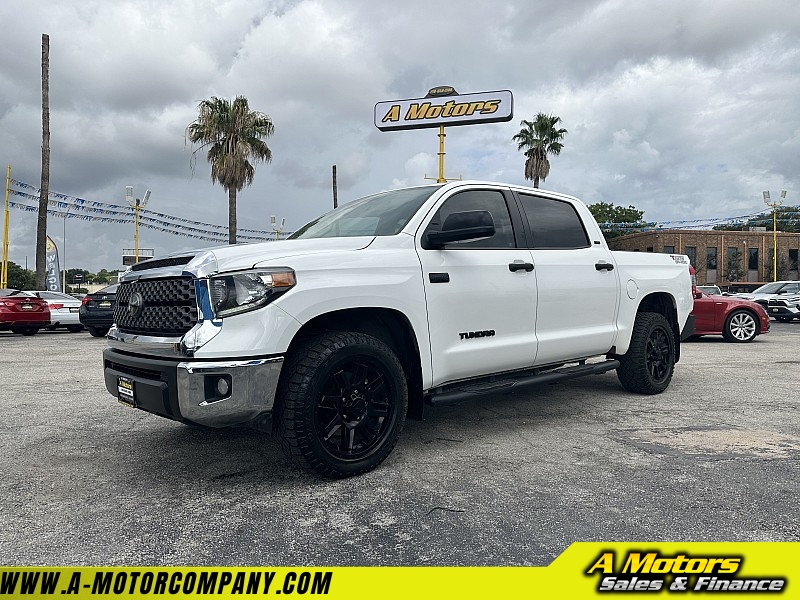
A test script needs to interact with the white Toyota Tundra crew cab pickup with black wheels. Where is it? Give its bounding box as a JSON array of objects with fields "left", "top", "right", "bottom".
[{"left": 103, "top": 181, "right": 693, "bottom": 477}]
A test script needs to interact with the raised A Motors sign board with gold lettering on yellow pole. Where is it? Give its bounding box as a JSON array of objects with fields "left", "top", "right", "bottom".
[{"left": 375, "top": 88, "right": 514, "bottom": 131}]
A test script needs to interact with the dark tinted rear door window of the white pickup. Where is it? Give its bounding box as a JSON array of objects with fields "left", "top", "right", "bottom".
[{"left": 520, "top": 194, "right": 589, "bottom": 248}]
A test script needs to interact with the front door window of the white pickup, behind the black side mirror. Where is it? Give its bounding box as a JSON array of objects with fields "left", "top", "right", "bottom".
[{"left": 425, "top": 190, "right": 516, "bottom": 250}]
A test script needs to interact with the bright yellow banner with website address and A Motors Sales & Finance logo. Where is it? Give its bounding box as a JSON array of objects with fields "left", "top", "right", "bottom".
[{"left": 0, "top": 542, "right": 800, "bottom": 600}]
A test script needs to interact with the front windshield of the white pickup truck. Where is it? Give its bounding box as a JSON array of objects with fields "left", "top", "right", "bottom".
[{"left": 288, "top": 185, "right": 440, "bottom": 240}]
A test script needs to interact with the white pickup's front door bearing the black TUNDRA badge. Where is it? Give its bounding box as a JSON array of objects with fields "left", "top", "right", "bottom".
[{"left": 417, "top": 188, "right": 537, "bottom": 385}]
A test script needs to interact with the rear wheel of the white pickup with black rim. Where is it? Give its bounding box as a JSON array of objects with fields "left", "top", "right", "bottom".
[{"left": 617, "top": 312, "right": 675, "bottom": 394}]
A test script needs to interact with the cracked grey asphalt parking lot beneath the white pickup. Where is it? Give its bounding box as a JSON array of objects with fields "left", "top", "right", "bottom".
[{"left": 0, "top": 322, "right": 800, "bottom": 566}]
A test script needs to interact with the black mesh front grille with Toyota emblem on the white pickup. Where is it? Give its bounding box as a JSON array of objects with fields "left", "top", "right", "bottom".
[{"left": 114, "top": 277, "right": 197, "bottom": 337}]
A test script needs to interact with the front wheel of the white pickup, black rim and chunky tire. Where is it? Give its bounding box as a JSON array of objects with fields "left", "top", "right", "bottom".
[{"left": 274, "top": 332, "right": 408, "bottom": 478}]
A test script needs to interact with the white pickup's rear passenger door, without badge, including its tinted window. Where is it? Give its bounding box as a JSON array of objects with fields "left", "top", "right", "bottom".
[{"left": 518, "top": 192, "right": 619, "bottom": 365}]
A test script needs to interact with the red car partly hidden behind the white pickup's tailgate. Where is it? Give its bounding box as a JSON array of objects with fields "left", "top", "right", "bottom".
[{"left": 692, "top": 290, "right": 770, "bottom": 343}]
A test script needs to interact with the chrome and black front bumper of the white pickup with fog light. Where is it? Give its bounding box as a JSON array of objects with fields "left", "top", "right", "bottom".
[{"left": 103, "top": 348, "right": 283, "bottom": 428}]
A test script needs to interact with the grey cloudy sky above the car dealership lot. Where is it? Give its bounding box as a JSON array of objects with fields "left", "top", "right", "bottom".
[{"left": 0, "top": 0, "right": 800, "bottom": 271}]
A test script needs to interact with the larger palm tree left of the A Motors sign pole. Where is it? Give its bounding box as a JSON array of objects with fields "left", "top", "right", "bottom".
[{"left": 186, "top": 96, "right": 275, "bottom": 244}]
